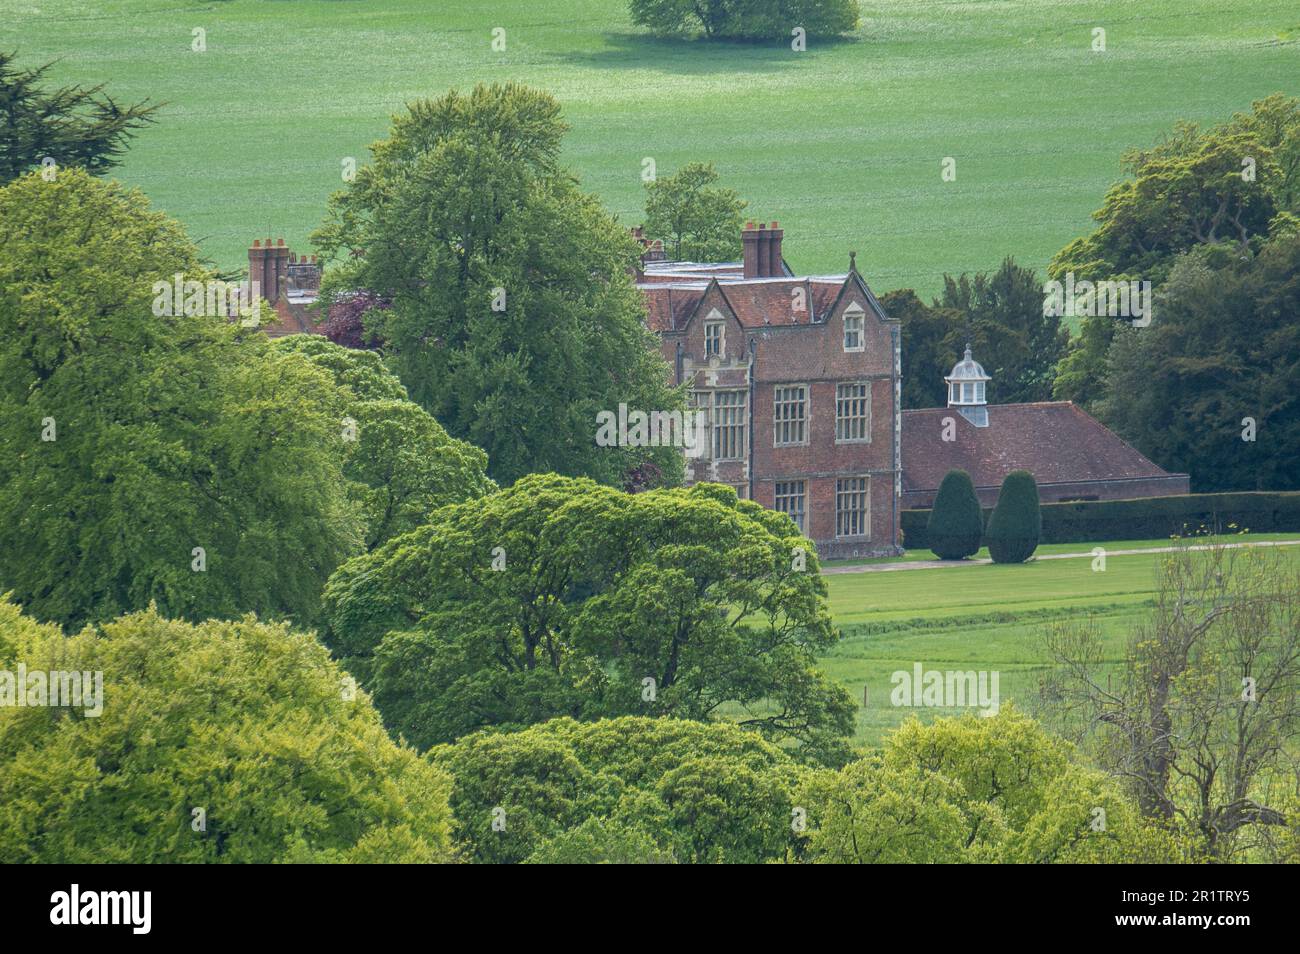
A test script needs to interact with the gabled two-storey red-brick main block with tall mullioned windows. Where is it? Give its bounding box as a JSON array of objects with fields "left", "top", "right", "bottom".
[{"left": 636, "top": 222, "right": 901, "bottom": 558}]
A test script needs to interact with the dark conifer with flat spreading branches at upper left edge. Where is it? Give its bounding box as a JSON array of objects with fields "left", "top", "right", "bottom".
[{"left": 0, "top": 51, "right": 161, "bottom": 185}]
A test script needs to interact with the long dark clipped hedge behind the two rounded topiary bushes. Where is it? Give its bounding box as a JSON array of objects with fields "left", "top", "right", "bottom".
[{"left": 901, "top": 491, "right": 1300, "bottom": 550}]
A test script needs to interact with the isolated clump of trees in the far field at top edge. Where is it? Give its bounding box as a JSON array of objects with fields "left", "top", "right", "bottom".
[{"left": 629, "top": 0, "right": 858, "bottom": 40}]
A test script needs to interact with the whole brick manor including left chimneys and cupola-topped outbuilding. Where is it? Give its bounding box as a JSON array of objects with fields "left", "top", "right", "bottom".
[{"left": 248, "top": 222, "right": 1188, "bottom": 559}]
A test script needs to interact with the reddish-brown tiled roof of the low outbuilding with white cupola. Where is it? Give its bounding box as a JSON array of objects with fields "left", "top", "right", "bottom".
[{"left": 900, "top": 402, "right": 1185, "bottom": 491}]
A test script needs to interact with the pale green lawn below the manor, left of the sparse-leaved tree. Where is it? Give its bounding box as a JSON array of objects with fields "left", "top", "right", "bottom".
[{"left": 822, "top": 534, "right": 1300, "bottom": 746}]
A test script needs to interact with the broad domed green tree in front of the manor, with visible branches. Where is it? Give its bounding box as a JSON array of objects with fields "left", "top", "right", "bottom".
[{"left": 322, "top": 474, "right": 854, "bottom": 763}]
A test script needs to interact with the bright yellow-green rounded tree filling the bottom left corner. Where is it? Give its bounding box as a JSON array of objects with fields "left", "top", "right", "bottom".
[{"left": 0, "top": 602, "right": 452, "bottom": 864}]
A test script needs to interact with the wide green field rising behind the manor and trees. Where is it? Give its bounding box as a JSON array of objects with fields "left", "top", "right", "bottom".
[{"left": 0, "top": 0, "right": 1300, "bottom": 292}]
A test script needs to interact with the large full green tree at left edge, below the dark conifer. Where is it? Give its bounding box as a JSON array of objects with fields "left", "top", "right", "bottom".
[{"left": 0, "top": 170, "right": 360, "bottom": 626}]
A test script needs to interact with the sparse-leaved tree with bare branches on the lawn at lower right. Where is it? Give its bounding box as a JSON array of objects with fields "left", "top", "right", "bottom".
[{"left": 1043, "top": 547, "right": 1300, "bottom": 860}]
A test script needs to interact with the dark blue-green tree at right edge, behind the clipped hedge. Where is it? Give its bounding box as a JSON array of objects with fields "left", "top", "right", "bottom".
[{"left": 1097, "top": 235, "right": 1300, "bottom": 491}]
